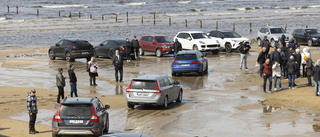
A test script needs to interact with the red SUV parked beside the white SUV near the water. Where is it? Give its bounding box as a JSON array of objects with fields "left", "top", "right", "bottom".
[{"left": 139, "top": 36, "right": 173, "bottom": 57}]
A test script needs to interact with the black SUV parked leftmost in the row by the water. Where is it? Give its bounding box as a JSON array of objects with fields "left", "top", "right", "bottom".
[{"left": 48, "top": 39, "right": 93, "bottom": 61}]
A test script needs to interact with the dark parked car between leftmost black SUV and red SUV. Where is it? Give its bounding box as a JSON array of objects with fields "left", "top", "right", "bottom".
[{"left": 93, "top": 40, "right": 135, "bottom": 59}]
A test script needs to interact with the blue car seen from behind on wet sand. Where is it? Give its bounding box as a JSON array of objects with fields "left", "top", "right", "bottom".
[{"left": 171, "top": 50, "right": 208, "bottom": 76}]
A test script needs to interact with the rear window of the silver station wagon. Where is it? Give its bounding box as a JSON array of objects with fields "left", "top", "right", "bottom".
[{"left": 130, "top": 80, "right": 156, "bottom": 90}]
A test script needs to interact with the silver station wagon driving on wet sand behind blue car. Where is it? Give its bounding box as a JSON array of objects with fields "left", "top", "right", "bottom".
[{"left": 126, "top": 75, "right": 183, "bottom": 109}]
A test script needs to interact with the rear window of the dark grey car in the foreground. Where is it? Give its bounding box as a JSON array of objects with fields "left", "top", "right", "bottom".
[{"left": 60, "top": 104, "right": 92, "bottom": 116}]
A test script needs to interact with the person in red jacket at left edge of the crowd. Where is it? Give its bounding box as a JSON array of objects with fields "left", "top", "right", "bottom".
[{"left": 262, "top": 59, "right": 272, "bottom": 93}]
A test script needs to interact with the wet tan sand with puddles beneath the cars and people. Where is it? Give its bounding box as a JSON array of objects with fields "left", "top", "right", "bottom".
[{"left": 0, "top": 44, "right": 320, "bottom": 137}]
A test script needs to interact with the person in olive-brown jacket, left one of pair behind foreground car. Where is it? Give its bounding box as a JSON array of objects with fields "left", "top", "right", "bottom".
[{"left": 56, "top": 68, "right": 66, "bottom": 103}]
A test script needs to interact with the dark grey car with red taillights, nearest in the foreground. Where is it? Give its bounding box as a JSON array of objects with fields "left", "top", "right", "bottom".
[{"left": 52, "top": 97, "right": 110, "bottom": 137}]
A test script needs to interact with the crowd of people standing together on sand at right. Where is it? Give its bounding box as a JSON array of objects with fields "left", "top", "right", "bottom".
[{"left": 257, "top": 36, "right": 320, "bottom": 96}]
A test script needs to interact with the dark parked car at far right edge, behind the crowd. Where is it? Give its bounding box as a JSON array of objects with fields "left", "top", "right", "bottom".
[{"left": 292, "top": 28, "right": 320, "bottom": 46}]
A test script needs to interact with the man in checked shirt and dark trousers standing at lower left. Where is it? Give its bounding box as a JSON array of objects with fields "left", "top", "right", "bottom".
[{"left": 27, "top": 89, "right": 39, "bottom": 134}]
